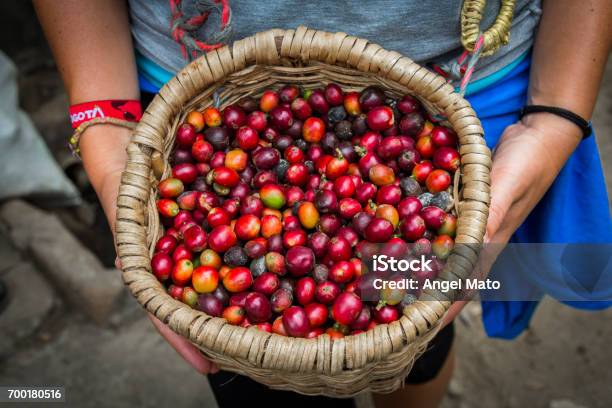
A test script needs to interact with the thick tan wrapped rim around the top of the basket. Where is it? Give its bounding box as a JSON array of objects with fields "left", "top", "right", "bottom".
[{"left": 116, "top": 26, "right": 491, "bottom": 371}]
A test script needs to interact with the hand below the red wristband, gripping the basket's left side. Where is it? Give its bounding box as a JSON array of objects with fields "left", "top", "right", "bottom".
[{"left": 81, "top": 125, "right": 219, "bottom": 374}]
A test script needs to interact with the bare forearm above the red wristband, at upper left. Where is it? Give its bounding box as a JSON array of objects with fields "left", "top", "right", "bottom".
[{"left": 34, "top": 0, "right": 139, "bottom": 104}]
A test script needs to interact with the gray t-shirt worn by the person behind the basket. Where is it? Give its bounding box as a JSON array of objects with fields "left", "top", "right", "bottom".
[{"left": 129, "top": 0, "right": 541, "bottom": 79}]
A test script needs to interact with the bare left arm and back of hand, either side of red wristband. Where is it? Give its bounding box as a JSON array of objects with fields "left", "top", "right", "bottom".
[{"left": 34, "top": 0, "right": 139, "bottom": 230}]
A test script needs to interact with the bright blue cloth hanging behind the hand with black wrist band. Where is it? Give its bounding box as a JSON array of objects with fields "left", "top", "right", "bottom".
[{"left": 468, "top": 58, "right": 612, "bottom": 339}]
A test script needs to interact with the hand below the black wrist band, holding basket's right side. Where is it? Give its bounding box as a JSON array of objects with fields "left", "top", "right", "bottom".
[{"left": 445, "top": 114, "right": 581, "bottom": 324}]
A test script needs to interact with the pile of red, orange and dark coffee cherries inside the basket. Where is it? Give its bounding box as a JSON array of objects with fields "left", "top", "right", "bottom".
[{"left": 151, "top": 83, "right": 460, "bottom": 338}]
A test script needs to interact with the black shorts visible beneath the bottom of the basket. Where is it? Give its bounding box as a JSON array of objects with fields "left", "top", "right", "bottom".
[{"left": 208, "top": 323, "right": 455, "bottom": 408}]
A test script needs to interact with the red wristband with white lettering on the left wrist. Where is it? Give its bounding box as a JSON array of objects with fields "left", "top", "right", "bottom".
[{"left": 70, "top": 100, "right": 142, "bottom": 129}]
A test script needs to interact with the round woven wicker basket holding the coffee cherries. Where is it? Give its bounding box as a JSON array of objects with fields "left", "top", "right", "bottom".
[{"left": 116, "top": 27, "right": 491, "bottom": 397}]
